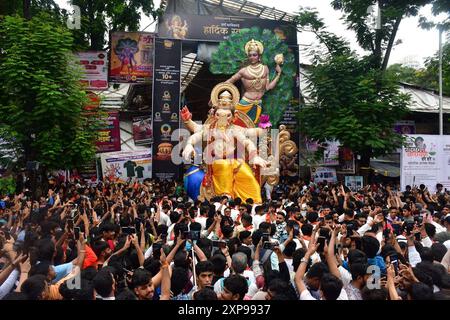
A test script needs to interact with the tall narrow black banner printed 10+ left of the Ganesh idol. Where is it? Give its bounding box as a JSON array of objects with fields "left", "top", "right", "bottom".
[{"left": 152, "top": 38, "right": 181, "bottom": 180}]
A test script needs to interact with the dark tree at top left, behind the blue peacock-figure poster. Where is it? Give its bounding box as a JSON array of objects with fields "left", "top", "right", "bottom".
[{"left": 70, "top": 0, "right": 165, "bottom": 50}]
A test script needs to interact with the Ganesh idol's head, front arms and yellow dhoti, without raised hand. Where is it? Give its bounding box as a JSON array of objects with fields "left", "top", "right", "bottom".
[{"left": 183, "top": 83, "right": 267, "bottom": 203}]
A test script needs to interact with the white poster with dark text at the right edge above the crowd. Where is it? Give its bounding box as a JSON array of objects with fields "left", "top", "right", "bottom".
[{"left": 400, "top": 135, "right": 450, "bottom": 192}]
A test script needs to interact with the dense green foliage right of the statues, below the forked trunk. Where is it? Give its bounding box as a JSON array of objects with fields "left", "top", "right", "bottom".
[{"left": 297, "top": 11, "right": 409, "bottom": 167}]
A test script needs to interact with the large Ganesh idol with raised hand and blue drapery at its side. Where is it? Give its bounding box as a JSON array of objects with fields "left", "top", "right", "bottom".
[{"left": 181, "top": 83, "right": 270, "bottom": 203}]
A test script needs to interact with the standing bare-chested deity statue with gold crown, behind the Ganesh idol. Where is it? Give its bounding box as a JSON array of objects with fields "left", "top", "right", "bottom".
[{"left": 226, "top": 39, "right": 283, "bottom": 124}]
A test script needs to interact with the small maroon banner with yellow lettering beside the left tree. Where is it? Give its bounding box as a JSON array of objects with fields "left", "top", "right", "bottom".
[{"left": 96, "top": 111, "right": 121, "bottom": 153}]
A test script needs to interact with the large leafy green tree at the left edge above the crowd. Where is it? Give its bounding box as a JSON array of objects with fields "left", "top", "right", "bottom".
[{"left": 0, "top": 14, "right": 100, "bottom": 180}]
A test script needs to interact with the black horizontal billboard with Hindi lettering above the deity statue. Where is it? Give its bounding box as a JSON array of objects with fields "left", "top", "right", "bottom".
[{"left": 158, "top": 13, "right": 297, "bottom": 46}]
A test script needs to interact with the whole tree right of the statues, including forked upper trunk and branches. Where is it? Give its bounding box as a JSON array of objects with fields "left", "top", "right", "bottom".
[{"left": 296, "top": 0, "right": 424, "bottom": 166}]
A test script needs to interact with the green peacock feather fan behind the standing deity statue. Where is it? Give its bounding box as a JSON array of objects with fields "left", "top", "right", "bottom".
[{"left": 210, "top": 27, "right": 296, "bottom": 126}]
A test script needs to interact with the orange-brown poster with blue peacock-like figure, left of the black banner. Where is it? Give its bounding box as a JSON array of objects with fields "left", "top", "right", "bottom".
[{"left": 109, "top": 32, "right": 154, "bottom": 83}]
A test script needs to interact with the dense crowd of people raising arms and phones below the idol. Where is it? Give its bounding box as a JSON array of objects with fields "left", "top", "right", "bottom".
[{"left": 0, "top": 179, "right": 450, "bottom": 300}]
